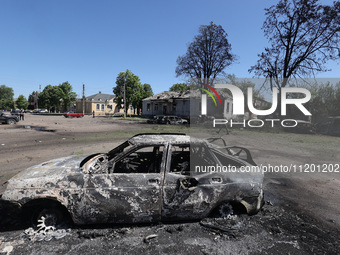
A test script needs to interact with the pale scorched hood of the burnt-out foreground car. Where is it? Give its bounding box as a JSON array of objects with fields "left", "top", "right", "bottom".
[{"left": 9, "top": 156, "right": 84, "bottom": 186}]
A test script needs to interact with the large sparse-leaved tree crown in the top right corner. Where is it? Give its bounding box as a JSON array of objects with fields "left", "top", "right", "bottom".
[{"left": 249, "top": 0, "right": 340, "bottom": 92}]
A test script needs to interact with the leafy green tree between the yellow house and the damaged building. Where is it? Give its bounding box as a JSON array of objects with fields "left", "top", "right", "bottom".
[{"left": 113, "top": 70, "right": 143, "bottom": 114}]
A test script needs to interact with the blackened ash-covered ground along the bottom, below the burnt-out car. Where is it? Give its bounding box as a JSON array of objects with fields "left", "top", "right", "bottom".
[{"left": 0, "top": 202, "right": 340, "bottom": 254}]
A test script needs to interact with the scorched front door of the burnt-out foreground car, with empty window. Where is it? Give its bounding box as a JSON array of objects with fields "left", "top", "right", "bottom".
[{"left": 85, "top": 145, "right": 165, "bottom": 223}]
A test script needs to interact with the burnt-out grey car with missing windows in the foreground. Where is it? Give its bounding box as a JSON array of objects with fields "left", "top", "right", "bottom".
[{"left": 1, "top": 134, "right": 263, "bottom": 224}]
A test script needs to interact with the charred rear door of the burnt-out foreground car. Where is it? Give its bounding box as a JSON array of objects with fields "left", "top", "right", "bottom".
[{"left": 162, "top": 144, "right": 222, "bottom": 220}]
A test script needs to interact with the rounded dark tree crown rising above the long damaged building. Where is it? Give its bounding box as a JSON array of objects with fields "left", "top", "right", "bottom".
[{"left": 176, "top": 22, "right": 236, "bottom": 79}]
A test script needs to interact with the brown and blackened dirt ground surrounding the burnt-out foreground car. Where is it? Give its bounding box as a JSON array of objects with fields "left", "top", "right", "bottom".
[{"left": 0, "top": 114, "right": 340, "bottom": 254}]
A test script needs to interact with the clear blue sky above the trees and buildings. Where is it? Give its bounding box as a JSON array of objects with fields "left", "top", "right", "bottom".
[{"left": 0, "top": 0, "right": 340, "bottom": 97}]
